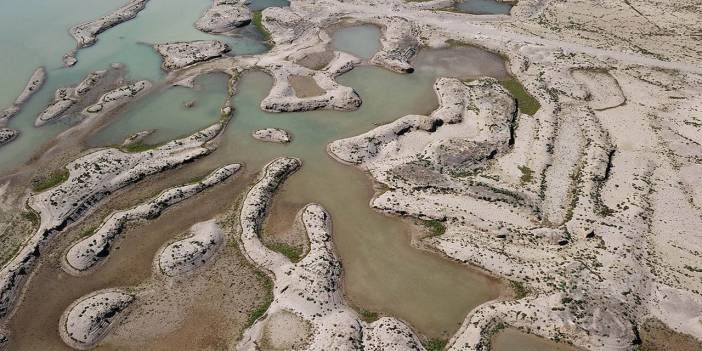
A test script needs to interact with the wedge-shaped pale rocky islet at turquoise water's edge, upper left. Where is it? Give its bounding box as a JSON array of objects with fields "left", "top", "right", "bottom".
[{"left": 154, "top": 40, "right": 229, "bottom": 71}]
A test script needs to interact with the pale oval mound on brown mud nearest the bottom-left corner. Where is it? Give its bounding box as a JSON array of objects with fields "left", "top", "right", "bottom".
[{"left": 59, "top": 289, "right": 134, "bottom": 350}]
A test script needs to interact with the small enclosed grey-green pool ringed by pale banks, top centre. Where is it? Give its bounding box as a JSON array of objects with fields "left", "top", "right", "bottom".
[{"left": 332, "top": 24, "right": 380, "bottom": 59}]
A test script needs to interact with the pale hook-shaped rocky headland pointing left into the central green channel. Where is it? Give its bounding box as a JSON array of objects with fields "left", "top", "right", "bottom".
[{"left": 329, "top": 78, "right": 516, "bottom": 174}]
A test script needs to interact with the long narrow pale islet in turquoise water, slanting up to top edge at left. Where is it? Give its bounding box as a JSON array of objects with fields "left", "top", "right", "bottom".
[{"left": 63, "top": 0, "right": 149, "bottom": 66}]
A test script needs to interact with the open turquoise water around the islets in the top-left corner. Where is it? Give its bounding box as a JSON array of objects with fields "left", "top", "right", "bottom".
[{"left": 0, "top": 0, "right": 267, "bottom": 174}]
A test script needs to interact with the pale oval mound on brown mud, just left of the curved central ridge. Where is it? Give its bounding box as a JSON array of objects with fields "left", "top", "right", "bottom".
[{"left": 156, "top": 220, "right": 224, "bottom": 277}]
